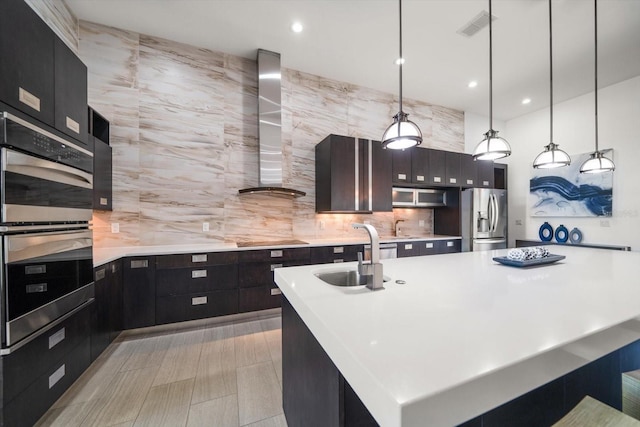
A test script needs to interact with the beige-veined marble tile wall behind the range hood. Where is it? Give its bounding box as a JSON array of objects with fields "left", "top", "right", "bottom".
[{"left": 78, "top": 21, "right": 464, "bottom": 247}]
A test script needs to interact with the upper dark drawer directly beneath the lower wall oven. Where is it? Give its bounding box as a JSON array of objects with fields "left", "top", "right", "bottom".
[{"left": 2, "top": 304, "right": 93, "bottom": 406}]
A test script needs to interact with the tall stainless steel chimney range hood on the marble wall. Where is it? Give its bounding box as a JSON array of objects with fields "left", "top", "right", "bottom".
[{"left": 238, "top": 49, "right": 306, "bottom": 197}]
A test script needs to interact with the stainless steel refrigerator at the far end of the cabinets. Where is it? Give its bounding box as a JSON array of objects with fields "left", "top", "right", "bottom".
[{"left": 460, "top": 188, "right": 507, "bottom": 252}]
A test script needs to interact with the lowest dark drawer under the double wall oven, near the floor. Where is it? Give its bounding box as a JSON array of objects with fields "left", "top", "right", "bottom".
[{"left": 3, "top": 336, "right": 91, "bottom": 427}]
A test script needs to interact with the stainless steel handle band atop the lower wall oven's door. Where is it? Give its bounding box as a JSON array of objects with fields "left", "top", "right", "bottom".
[{"left": 5, "top": 230, "right": 93, "bottom": 262}]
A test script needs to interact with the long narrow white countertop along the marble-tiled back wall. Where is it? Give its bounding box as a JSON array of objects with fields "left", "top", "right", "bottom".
[{"left": 93, "top": 233, "right": 461, "bottom": 266}]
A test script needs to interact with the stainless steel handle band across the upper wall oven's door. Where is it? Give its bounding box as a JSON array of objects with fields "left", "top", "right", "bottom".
[{"left": 2, "top": 150, "right": 93, "bottom": 189}]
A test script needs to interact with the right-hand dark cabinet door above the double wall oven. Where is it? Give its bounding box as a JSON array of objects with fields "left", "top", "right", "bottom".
[{"left": 54, "top": 37, "right": 88, "bottom": 145}]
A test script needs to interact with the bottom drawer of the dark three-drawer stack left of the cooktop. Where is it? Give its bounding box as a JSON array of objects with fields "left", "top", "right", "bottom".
[{"left": 156, "top": 289, "right": 238, "bottom": 324}]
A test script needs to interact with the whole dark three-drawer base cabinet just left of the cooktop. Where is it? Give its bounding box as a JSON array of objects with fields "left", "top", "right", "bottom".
[{"left": 156, "top": 252, "right": 238, "bottom": 324}]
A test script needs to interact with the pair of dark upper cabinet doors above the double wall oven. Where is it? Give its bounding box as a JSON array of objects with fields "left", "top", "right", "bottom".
[{"left": 0, "top": 0, "right": 90, "bottom": 149}]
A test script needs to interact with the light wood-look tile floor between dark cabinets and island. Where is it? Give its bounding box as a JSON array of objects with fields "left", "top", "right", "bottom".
[{"left": 36, "top": 314, "right": 287, "bottom": 427}]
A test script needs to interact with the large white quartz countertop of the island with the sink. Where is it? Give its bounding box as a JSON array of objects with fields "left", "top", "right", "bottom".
[{"left": 275, "top": 246, "right": 640, "bottom": 427}]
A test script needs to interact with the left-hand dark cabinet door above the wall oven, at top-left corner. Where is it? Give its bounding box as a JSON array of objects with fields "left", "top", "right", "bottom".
[{"left": 0, "top": 0, "right": 55, "bottom": 126}]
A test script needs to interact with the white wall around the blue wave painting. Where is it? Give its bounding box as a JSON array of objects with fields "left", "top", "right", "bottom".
[{"left": 500, "top": 76, "right": 640, "bottom": 251}]
